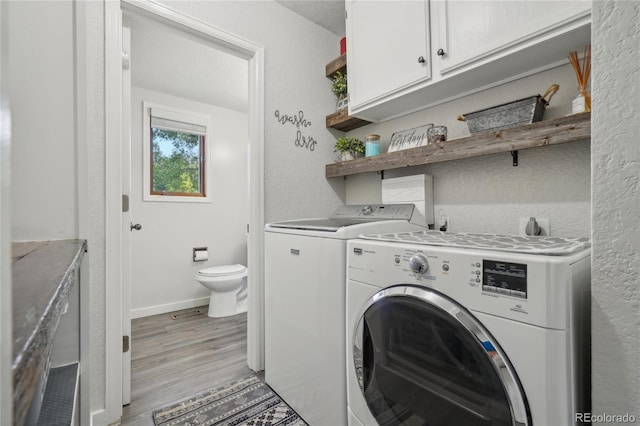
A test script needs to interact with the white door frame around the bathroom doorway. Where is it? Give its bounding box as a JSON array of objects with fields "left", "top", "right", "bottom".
[{"left": 104, "top": 0, "right": 264, "bottom": 420}]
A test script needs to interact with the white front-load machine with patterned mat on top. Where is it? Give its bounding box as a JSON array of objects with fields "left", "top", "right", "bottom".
[{"left": 346, "top": 231, "right": 590, "bottom": 426}]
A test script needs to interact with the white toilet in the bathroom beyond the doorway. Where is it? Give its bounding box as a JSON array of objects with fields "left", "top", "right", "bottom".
[{"left": 196, "top": 264, "right": 248, "bottom": 318}]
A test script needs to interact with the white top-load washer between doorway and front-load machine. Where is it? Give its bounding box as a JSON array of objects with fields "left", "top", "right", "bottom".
[{"left": 265, "top": 204, "right": 426, "bottom": 426}]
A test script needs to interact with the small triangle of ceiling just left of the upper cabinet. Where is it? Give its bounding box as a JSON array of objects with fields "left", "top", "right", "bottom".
[{"left": 276, "top": 0, "right": 346, "bottom": 37}]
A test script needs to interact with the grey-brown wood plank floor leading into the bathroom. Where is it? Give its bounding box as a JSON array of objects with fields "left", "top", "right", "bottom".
[{"left": 121, "top": 306, "right": 251, "bottom": 426}]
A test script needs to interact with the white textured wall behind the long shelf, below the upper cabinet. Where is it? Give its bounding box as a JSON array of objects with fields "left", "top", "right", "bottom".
[{"left": 347, "top": 64, "right": 591, "bottom": 236}]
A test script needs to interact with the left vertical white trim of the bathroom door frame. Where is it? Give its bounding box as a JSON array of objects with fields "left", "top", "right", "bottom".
[{"left": 104, "top": 1, "right": 122, "bottom": 424}]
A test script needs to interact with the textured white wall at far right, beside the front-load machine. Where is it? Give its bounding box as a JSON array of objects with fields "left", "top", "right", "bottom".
[{"left": 591, "top": 1, "right": 640, "bottom": 421}]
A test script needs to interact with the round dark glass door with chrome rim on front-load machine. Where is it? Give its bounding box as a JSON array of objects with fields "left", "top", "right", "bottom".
[{"left": 353, "top": 285, "right": 531, "bottom": 426}]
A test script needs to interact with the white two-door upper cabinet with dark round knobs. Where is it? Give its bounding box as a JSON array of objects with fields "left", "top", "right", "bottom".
[{"left": 346, "top": 0, "right": 591, "bottom": 121}]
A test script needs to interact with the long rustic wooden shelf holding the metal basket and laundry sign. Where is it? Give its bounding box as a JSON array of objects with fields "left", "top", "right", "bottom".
[{"left": 325, "top": 113, "right": 591, "bottom": 178}]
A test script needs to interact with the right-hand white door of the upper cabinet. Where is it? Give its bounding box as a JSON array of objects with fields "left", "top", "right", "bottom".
[{"left": 434, "top": 0, "right": 591, "bottom": 75}]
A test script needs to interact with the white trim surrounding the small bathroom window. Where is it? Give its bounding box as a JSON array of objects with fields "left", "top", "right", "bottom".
[{"left": 142, "top": 101, "right": 213, "bottom": 203}]
